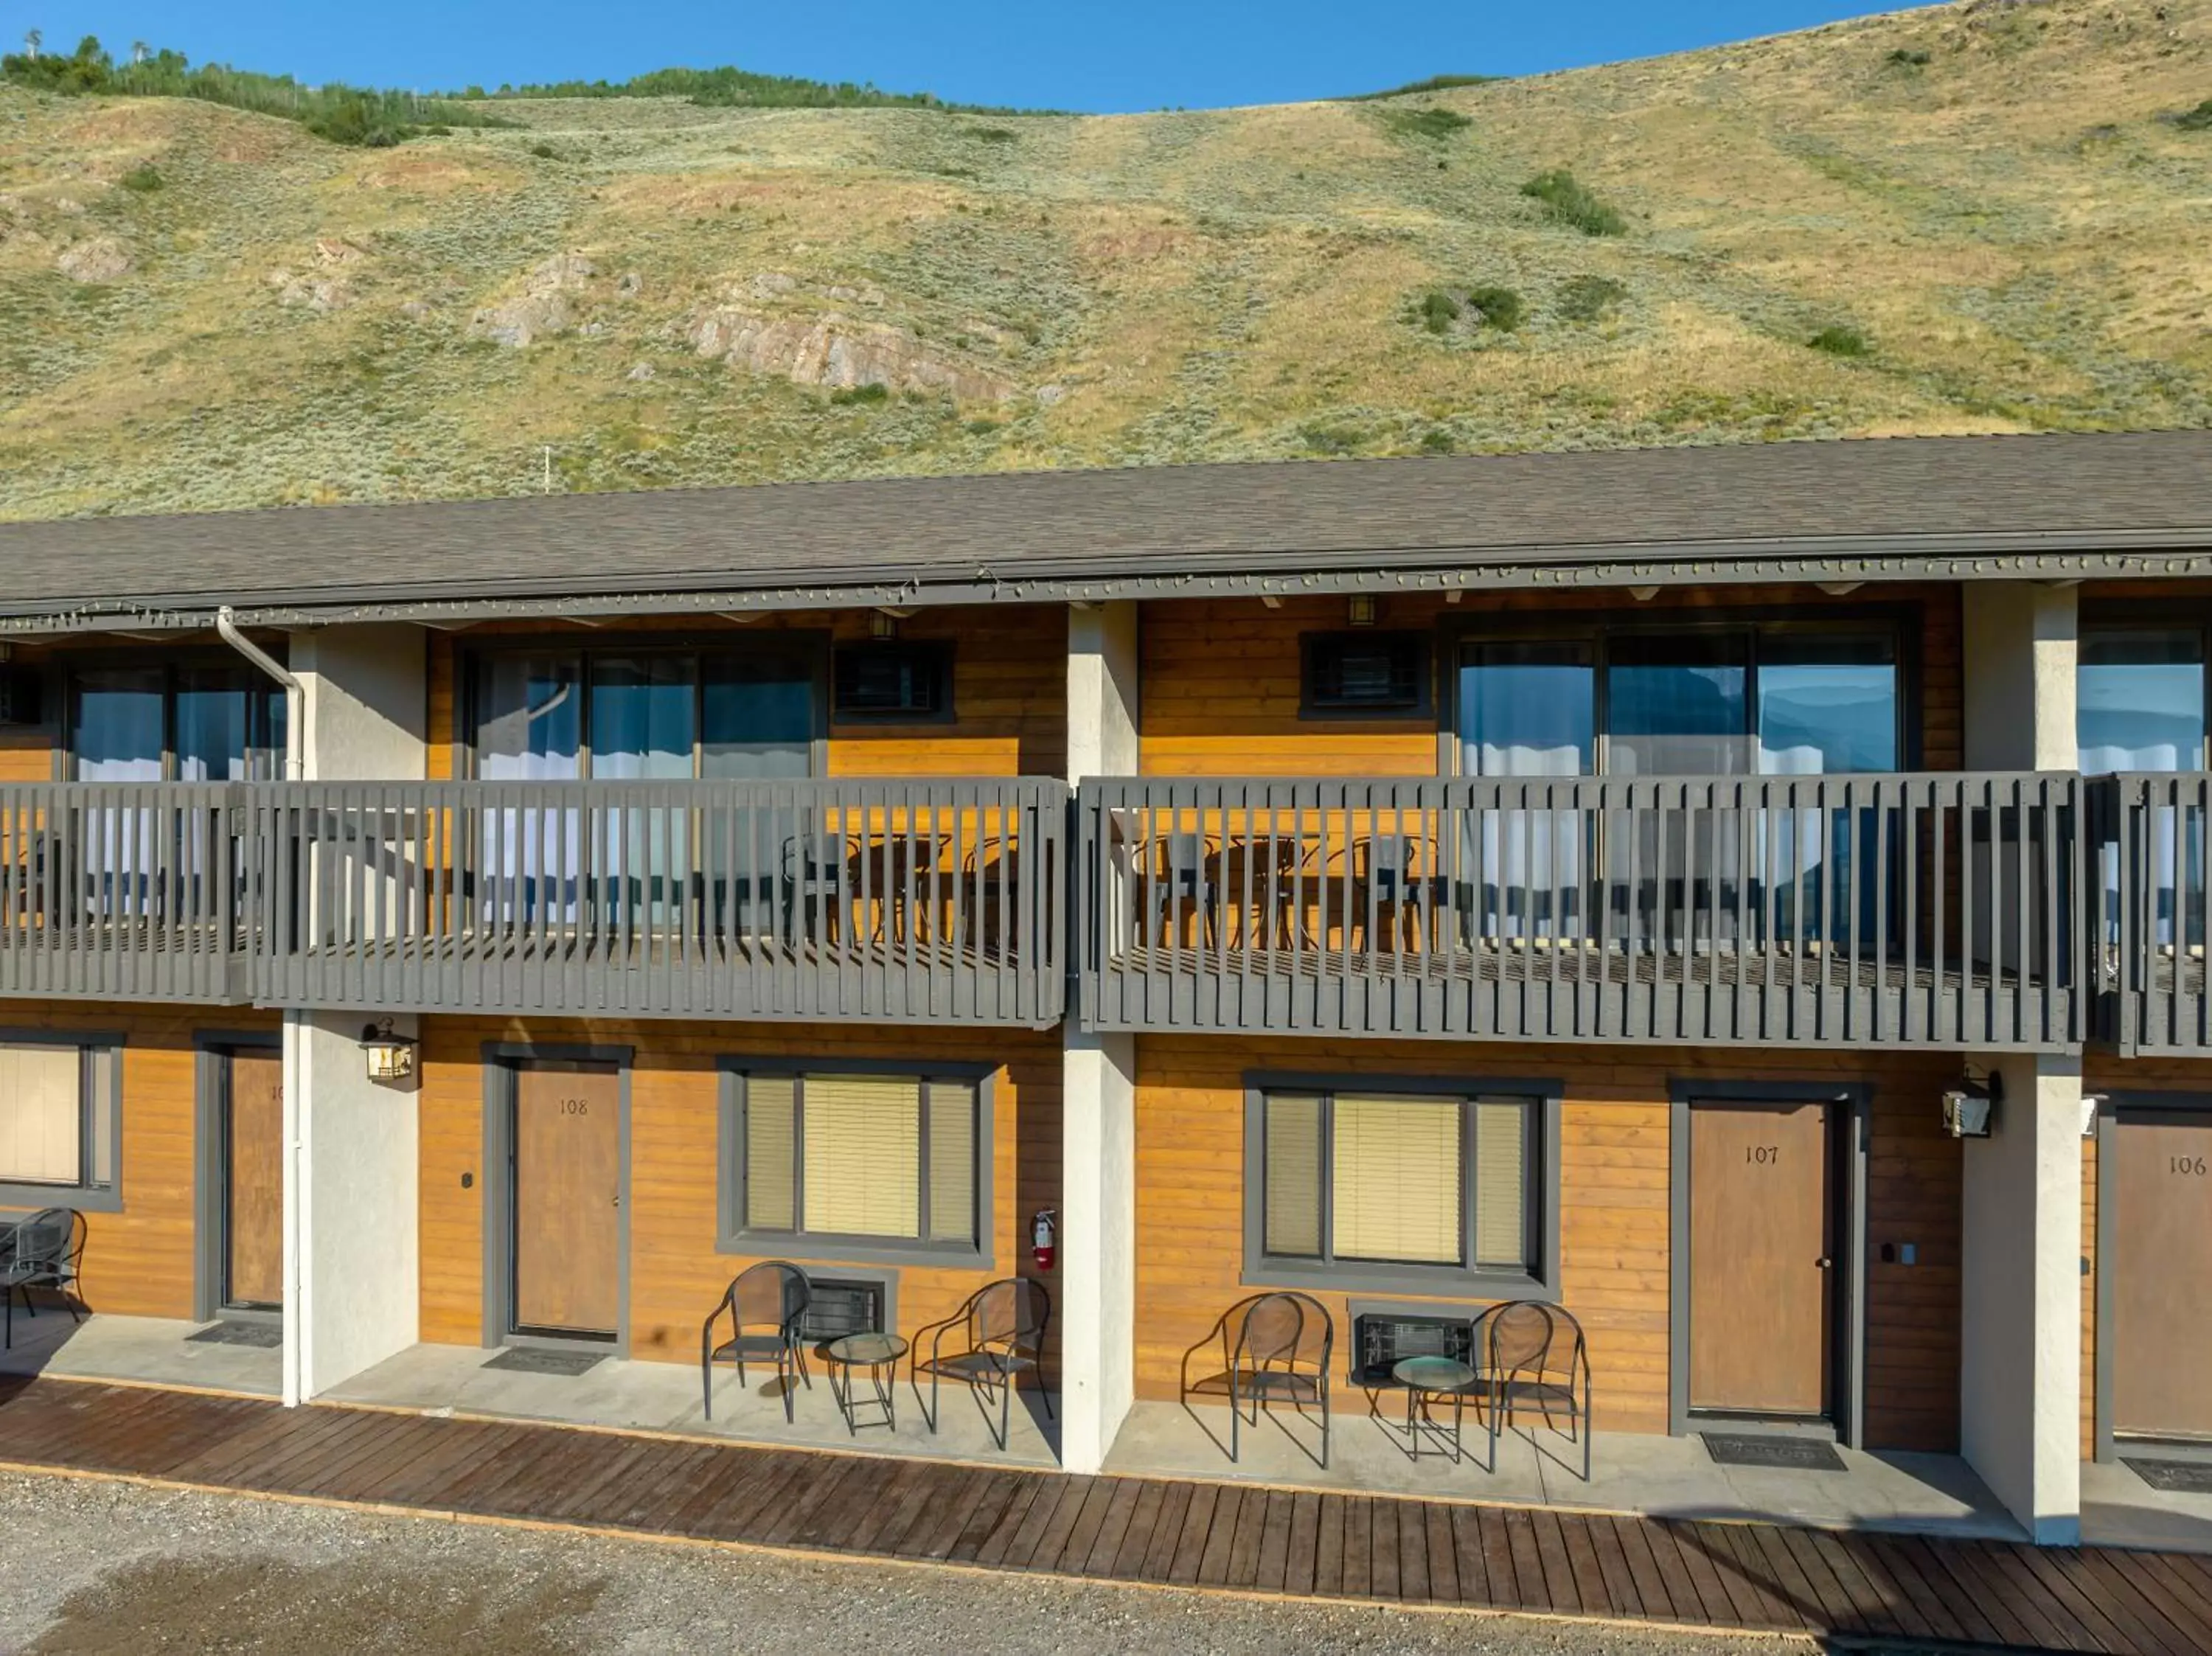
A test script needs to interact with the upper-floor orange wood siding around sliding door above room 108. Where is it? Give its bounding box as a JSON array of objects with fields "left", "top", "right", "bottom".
[{"left": 429, "top": 604, "right": 1068, "bottom": 781}]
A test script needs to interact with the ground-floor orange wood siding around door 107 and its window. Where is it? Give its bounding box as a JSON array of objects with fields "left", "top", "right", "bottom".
[{"left": 1137, "top": 1034, "right": 1960, "bottom": 1450}]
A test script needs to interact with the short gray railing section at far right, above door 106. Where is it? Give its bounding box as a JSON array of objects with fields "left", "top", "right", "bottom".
[{"left": 2088, "top": 772, "right": 2212, "bottom": 1054}]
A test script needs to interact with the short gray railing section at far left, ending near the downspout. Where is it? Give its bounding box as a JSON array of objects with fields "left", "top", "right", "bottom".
[{"left": 0, "top": 783, "right": 250, "bottom": 1001}]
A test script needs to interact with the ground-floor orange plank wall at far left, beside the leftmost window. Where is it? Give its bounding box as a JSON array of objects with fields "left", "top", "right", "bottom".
[{"left": 0, "top": 1001, "right": 276, "bottom": 1318}]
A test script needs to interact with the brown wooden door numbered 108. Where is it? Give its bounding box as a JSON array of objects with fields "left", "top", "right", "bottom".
[{"left": 513, "top": 1063, "right": 622, "bottom": 1337}]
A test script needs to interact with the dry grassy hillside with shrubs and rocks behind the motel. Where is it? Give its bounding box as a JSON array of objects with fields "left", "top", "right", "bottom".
[{"left": 0, "top": 0, "right": 2212, "bottom": 518}]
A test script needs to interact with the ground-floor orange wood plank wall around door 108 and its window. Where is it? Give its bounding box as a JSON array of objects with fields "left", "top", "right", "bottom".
[{"left": 420, "top": 1017, "right": 1060, "bottom": 1362}]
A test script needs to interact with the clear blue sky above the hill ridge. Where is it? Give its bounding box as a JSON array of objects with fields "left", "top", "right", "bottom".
[{"left": 17, "top": 0, "right": 1911, "bottom": 111}]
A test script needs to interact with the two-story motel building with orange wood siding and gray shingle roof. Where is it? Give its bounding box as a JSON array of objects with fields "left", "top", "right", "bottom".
[{"left": 0, "top": 431, "right": 2212, "bottom": 1543}]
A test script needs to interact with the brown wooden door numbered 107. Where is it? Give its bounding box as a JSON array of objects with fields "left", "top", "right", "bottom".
[{"left": 1690, "top": 1103, "right": 1836, "bottom": 1417}]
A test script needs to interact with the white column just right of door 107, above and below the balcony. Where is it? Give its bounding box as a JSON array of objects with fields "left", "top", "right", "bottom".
[{"left": 1964, "top": 582, "right": 2081, "bottom": 1545}]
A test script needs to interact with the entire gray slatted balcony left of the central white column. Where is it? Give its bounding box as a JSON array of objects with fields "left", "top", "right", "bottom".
[{"left": 0, "top": 781, "right": 1066, "bottom": 1028}]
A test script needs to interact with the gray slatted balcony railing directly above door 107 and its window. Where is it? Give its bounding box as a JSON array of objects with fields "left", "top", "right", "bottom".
[{"left": 1077, "top": 774, "right": 2086, "bottom": 1048}]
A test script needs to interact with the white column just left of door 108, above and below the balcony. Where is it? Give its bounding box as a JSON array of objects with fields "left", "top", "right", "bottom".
[{"left": 285, "top": 626, "right": 427, "bottom": 1402}]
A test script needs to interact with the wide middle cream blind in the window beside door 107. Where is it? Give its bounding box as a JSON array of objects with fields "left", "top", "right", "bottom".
[{"left": 1329, "top": 1094, "right": 1464, "bottom": 1264}]
